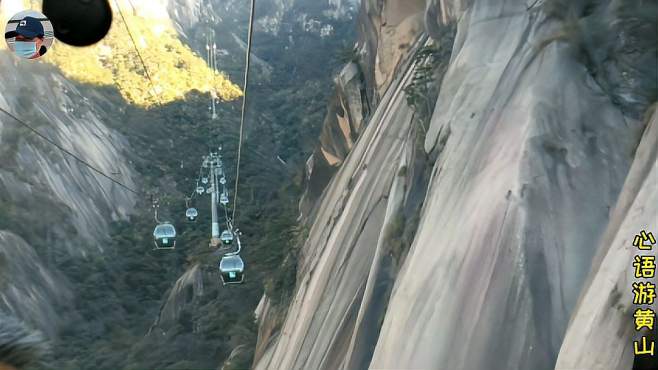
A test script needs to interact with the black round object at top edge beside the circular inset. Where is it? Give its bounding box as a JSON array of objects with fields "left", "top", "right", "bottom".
[{"left": 43, "top": 0, "right": 112, "bottom": 46}]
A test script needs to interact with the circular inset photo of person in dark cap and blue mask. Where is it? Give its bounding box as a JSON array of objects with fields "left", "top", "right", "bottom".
[{"left": 5, "top": 10, "right": 55, "bottom": 59}]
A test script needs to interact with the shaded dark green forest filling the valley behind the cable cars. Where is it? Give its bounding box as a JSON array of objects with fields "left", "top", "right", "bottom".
[{"left": 43, "top": 12, "right": 356, "bottom": 369}]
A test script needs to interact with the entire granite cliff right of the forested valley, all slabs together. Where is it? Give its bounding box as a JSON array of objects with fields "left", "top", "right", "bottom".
[{"left": 255, "top": 0, "right": 658, "bottom": 370}]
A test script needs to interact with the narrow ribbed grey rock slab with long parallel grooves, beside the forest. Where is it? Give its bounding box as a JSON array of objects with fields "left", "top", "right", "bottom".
[{"left": 255, "top": 39, "right": 413, "bottom": 369}]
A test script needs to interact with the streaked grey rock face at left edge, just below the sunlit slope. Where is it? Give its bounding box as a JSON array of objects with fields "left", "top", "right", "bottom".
[{"left": 0, "top": 52, "right": 135, "bottom": 253}]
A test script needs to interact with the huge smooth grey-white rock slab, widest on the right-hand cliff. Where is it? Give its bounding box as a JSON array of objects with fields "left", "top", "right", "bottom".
[{"left": 370, "top": 1, "right": 641, "bottom": 369}]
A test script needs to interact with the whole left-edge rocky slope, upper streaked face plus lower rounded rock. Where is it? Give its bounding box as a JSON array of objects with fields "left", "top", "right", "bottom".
[{"left": 0, "top": 53, "right": 135, "bottom": 335}]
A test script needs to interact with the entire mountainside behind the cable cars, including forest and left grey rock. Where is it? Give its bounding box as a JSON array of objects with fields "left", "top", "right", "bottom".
[{"left": 0, "top": 0, "right": 353, "bottom": 369}]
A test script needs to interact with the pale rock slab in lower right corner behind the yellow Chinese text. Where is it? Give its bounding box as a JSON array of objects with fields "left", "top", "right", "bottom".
[{"left": 555, "top": 109, "right": 658, "bottom": 370}]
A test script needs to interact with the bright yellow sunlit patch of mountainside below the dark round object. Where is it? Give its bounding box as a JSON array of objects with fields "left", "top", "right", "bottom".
[{"left": 45, "top": 8, "right": 242, "bottom": 107}]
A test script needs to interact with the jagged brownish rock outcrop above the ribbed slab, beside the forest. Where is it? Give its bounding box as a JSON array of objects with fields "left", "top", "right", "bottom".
[{"left": 300, "top": 0, "right": 424, "bottom": 218}]
